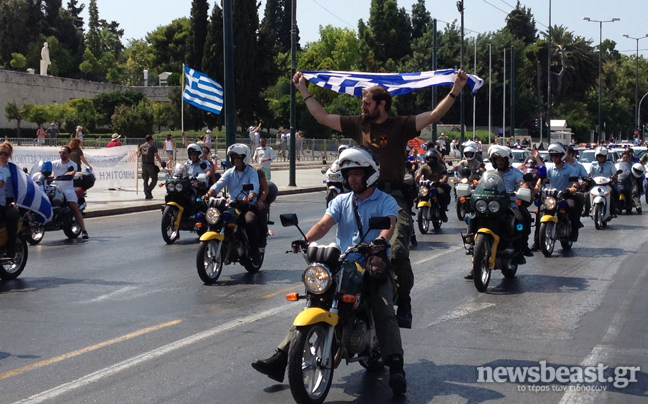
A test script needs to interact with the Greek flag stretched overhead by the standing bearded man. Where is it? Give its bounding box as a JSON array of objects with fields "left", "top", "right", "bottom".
[{"left": 302, "top": 69, "right": 484, "bottom": 97}]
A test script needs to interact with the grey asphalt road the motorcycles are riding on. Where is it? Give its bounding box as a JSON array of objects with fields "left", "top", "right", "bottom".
[{"left": 0, "top": 192, "right": 648, "bottom": 404}]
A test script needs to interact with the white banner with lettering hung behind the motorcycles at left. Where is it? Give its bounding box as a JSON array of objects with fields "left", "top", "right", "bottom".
[{"left": 11, "top": 146, "right": 137, "bottom": 189}]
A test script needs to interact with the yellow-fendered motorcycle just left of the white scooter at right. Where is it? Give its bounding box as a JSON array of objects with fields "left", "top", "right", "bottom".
[{"left": 538, "top": 188, "right": 573, "bottom": 257}]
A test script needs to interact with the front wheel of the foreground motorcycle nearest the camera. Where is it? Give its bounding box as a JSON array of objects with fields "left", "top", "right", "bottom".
[{"left": 288, "top": 323, "right": 333, "bottom": 404}]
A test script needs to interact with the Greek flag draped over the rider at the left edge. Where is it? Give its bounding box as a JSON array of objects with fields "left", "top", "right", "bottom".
[{"left": 8, "top": 163, "right": 52, "bottom": 224}]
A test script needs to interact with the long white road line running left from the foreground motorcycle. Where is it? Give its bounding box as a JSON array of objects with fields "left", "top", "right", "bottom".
[{"left": 9, "top": 305, "right": 286, "bottom": 404}]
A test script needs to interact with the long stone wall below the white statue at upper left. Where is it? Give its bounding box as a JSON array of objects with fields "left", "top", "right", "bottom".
[{"left": 0, "top": 70, "right": 171, "bottom": 129}]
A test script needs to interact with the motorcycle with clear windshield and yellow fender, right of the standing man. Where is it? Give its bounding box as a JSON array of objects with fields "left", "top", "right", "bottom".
[{"left": 457, "top": 171, "right": 531, "bottom": 292}]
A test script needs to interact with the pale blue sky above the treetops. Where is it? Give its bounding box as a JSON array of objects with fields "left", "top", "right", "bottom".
[{"left": 81, "top": 0, "right": 648, "bottom": 58}]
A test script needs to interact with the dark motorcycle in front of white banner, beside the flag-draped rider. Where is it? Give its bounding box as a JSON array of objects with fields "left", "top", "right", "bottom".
[{"left": 22, "top": 161, "right": 95, "bottom": 245}]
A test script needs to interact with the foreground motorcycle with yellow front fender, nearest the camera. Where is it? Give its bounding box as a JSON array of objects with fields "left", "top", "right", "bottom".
[{"left": 280, "top": 213, "right": 390, "bottom": 404}]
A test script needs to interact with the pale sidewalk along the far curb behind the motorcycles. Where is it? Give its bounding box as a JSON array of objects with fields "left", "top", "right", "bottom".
[{"left": 85, "top": 163, "right": 325, "bottom": 217}]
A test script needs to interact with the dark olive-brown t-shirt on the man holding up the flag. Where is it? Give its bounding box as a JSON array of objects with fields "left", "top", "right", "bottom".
[{"left": 340, "top": 115, "right": 420, "bottom": 184}]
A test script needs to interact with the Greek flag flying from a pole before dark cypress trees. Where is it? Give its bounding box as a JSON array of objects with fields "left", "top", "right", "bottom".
[{"left": 182, "top": 66, "right": 223, "bottom": 114}]
